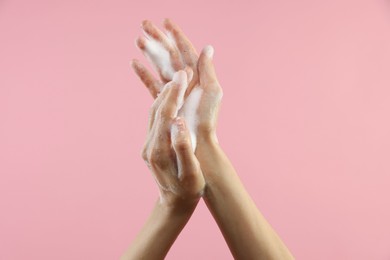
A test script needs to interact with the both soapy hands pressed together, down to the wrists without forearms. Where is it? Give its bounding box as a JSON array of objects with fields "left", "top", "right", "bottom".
[{"left": 132, "top": 19, "right": 222, "bottom": 208}]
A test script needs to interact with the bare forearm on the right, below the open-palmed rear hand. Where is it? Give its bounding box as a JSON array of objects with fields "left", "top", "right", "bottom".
[{"left": 197, "top": 142, "right": 293, "bottom": 260}]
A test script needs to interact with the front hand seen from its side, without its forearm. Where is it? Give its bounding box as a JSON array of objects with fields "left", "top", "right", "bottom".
[{"left": 142, "top": 71, "right": 205, "bottom": 208}]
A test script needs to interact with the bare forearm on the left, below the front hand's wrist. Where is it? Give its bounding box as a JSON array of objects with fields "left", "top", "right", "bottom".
[{"left": 121, "top": 200, "right": 196, "bottom": 260}]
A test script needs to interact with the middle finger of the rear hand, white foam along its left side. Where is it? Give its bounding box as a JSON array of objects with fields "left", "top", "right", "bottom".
[{"left": 142, "top": 20, "right": 184, "bottom": 80}]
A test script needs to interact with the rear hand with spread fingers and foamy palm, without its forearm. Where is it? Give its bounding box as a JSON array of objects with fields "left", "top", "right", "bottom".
[{"left": 132, "top": 19, "right": 222, "bottom": 150}]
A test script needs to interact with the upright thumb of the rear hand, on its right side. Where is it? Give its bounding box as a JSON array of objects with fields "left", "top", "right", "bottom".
[{"left": 198, "top": 45, "right": 219, "bottom": 87}]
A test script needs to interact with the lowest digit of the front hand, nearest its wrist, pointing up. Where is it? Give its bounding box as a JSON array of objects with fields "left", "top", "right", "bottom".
[{"left": 171, "top": 117, "right": 204, "bottom": 190}]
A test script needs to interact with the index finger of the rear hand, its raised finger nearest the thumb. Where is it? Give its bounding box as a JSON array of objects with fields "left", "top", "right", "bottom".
[{"left": 163, "top": 18, "right": 198, "bottom": 69}]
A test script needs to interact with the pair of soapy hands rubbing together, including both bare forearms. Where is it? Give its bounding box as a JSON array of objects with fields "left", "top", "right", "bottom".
[{"left": 128, "top": 19, "right": 294, "bottom": 260}]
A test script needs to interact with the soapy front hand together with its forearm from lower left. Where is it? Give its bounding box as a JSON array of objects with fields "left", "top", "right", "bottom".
[{"left": 121, "top": 71, "right": 205, "bottom": 260}]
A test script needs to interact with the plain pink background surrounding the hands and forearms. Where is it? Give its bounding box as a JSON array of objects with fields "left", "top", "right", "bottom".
[{"left": 0, "top": 0, "right": 390, "bottom": 260}]
